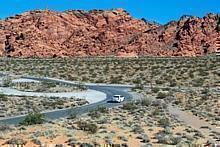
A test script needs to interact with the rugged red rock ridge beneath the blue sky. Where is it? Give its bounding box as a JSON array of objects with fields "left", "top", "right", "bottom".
[{"left": 0, "top": 9, "right": 219, "bottom": 57}]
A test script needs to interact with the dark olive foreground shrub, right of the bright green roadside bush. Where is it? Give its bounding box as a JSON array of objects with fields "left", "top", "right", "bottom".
[{"left": 77, "top": 121, "right": 98, "bottom": 134}]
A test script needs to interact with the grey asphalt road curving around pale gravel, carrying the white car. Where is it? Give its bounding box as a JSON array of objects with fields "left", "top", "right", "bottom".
[{"left": 0, "top": 76, "right": 132, "bottom": 125}]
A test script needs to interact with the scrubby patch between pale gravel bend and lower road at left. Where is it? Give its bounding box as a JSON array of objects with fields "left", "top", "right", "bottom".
[{"left": 0, "top": 94, "right": 88, "bottom": 117}]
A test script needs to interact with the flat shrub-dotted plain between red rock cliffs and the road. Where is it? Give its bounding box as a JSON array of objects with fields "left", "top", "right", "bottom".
[{"left": 0, "top": 57, "right": 217, "bottom": 89}]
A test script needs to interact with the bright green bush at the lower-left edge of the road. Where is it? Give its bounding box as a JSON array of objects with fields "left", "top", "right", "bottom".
[{"left": 21, "top": 112, "right": 45, "bottom": 126}]
